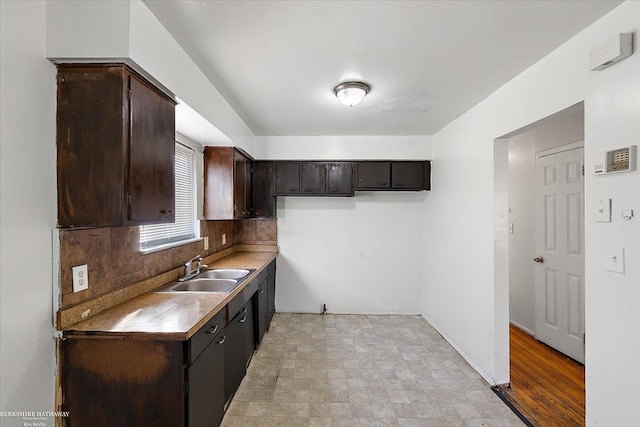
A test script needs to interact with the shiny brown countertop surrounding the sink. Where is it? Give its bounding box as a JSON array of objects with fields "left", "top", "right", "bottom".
[{"left": 63, "top": 252, "right": 278, "bottom": 341}]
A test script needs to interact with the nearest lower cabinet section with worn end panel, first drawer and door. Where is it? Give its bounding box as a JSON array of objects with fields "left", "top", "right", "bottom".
[{"left": 62, "top": 310, "right": 226, "bottom": 427}]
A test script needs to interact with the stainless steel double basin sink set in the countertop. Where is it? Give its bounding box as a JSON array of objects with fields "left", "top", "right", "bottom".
[{"left": 155, "top": 268, "right": 254, "bottom": 293}]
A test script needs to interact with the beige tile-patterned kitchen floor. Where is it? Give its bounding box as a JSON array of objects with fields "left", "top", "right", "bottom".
[{"left": 222, "top": 314, "right": 523, "bottom": 427}]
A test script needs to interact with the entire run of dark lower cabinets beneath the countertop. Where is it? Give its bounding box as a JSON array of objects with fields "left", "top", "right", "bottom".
[{"left": 62, "top": 266, "right": 275, "bottom": 427}]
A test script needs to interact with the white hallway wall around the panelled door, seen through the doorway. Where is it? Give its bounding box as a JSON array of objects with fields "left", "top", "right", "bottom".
[{"left": 508, "top": 108, "right": 584, "bottom": 334}]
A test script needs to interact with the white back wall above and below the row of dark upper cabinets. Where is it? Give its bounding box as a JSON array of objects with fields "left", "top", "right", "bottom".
[{"left": 256, "top": 136, "right": 431, "bottom": 314}]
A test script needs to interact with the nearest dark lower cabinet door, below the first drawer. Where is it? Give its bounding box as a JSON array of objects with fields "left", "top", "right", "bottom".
[{"left": 187, "top": 331, "right": 226, "bottom": 427}]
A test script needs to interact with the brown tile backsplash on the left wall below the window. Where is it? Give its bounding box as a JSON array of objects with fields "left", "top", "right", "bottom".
[{"left": 59, "top": 221, "right": 236, "bottom": 308}]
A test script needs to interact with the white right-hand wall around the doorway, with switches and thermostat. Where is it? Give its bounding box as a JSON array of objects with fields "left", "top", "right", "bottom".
[{"left": 423, "top": 2, "right": 640, "bottom": 426}]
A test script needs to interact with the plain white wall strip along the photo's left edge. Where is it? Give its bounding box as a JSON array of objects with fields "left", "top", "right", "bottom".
[{"left": 0, "top": 1, "right": 56, "bottom": 427}]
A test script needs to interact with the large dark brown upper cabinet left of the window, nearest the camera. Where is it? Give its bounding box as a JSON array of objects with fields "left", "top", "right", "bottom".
[{"left": 56, "top": 64, "right": 175, "bottom": 227}]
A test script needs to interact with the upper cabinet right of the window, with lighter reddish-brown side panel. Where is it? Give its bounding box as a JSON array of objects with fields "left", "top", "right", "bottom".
[{"left": 204, "top": 147, "right": 253, "bottom": 220}]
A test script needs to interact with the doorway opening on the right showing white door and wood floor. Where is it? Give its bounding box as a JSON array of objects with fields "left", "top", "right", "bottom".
[{"left": 495, "top": 103, "right": 584, "bottom": 425}]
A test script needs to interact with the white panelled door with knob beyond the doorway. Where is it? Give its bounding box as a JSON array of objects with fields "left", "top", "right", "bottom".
[{"left": 533, "top": 147, "right": 584, "bottom": 363}]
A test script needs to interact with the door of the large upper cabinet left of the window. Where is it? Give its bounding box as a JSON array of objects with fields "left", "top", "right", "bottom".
[{"left": 128, "top": 75, "right": 175, "bottom": 223}]
